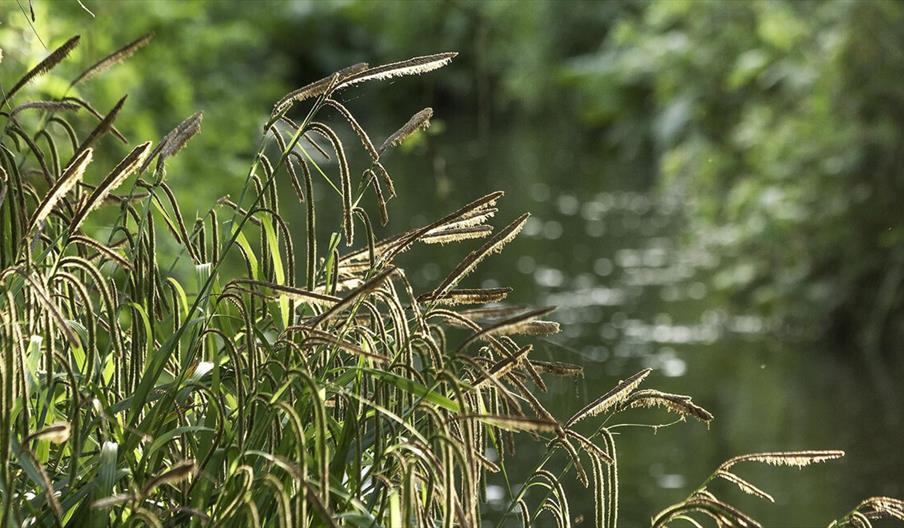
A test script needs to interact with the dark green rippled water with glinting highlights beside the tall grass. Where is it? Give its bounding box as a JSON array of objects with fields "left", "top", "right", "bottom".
[{"left": 300, "top": 111, "right": 904, "bottom": 527}]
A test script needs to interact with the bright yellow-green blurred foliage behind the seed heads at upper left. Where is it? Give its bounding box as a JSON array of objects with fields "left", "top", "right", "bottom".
[{"left": 0, "top": 0, "right": 288, "bottom": 210}]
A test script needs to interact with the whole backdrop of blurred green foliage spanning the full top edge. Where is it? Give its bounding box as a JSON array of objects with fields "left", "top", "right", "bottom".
[{"left": 7, "top": 0, "right": 904, "bottom": 353}]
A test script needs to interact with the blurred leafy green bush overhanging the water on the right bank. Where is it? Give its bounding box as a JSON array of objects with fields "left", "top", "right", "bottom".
[{"left": 572, "top": 0, "right": 904, "bottom": 358}]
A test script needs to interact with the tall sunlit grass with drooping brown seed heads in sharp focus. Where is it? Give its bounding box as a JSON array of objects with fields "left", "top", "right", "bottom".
[{"left": 0, "top": 32, "right": 902, "bottom": 527}]
